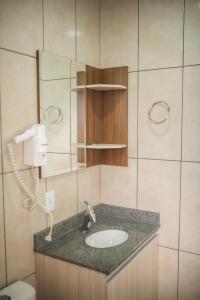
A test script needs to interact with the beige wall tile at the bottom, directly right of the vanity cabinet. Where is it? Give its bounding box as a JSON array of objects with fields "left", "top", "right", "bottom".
[{"left": 158, "top": 247, "right": 178, "bottom": 300}]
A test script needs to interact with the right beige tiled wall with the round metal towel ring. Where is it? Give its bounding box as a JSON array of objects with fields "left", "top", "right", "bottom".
[{"left": 100, "top": 0, "right": 200, "bottom": 300}]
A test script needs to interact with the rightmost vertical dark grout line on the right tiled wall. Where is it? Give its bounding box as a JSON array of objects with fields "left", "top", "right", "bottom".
[{"left": 177, "top": 0, "right": 185, "bottom": 299}]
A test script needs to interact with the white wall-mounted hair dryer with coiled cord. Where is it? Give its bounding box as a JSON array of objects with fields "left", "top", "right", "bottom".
[{"left": 8, "top": 124, "right": 53, "bottom": 241}]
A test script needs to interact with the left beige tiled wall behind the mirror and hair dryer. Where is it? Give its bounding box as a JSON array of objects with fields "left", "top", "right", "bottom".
[{"left": 0, "top": 0, "right": 100, "bottom": 287}]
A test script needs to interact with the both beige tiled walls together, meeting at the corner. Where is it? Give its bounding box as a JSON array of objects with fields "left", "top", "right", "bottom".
[{"left": 0, "top": 0, "right": 200, "bottom": 300}]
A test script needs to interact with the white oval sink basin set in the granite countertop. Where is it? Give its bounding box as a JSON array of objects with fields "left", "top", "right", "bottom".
[{"left": 85, "top": 229, "right": 128, "bottom": 248}]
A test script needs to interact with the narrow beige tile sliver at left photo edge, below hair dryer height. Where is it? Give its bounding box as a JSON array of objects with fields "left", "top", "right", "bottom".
[{"left": 0, "top": 175, "right": 6, "bottom": 288}]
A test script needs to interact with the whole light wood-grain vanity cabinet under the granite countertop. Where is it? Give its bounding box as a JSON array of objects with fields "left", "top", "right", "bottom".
[{"left": 36, "top": 237, "right": 157, "bottom": 300}]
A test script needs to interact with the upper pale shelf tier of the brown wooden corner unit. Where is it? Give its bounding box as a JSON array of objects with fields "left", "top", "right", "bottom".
[{"left": 72, "top": 84, "right": 127, "bottom": 91}]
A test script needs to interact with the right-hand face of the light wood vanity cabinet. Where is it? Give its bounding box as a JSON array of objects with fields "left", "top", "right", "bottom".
[{"left": 106, "top": 238, "right": 157, "bottom": 300}]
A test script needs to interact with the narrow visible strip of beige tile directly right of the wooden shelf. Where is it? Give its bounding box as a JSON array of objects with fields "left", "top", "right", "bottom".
[{"left": 128, "top": 73, "right": 137, "bottom": 157}]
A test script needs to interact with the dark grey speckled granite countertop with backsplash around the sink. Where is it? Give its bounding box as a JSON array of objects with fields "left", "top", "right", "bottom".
[{"left": 34, "top": 204, "right": 160, "bottom": 275}]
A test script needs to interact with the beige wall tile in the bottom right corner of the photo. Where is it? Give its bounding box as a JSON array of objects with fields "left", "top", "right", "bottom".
[{"left": 179, "top": 252, "right": 200, "bottom": 300}]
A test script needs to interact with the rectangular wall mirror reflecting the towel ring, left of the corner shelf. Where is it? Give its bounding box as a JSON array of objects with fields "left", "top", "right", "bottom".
[{"left": 37, "top": 51, "right": 86, "bottom": 178}]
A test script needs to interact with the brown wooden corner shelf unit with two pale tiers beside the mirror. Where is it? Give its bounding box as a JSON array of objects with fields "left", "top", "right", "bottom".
[{"left": 76, "top": 66, "right": 128, "bottom": 167}]
